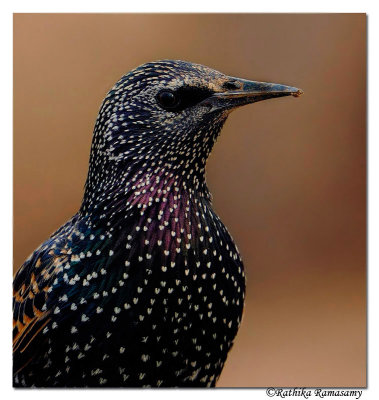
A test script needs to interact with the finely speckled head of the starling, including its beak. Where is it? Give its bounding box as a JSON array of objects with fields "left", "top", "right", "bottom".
[{"left": 86, "top": 60, "right": 302, "bottom": 212}]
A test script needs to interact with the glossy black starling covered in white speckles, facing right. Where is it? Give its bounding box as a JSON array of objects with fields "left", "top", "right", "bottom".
[{"left": 13, "top": 60, "right": 302, "bottom": 387}]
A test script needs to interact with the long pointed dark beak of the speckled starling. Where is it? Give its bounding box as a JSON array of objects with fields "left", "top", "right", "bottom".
[{"left": 204, "top": 77, "right": 303, "bottom": 111}]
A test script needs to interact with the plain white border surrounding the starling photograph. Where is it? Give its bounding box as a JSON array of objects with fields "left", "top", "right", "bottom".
[{"left": 0, "top": 0, "right": 379, "bottom": 400}]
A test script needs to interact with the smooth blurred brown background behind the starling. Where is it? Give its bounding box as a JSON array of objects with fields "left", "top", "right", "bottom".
[{"left": 14, "top": 14, "right": 366, "bottom": 387}]
